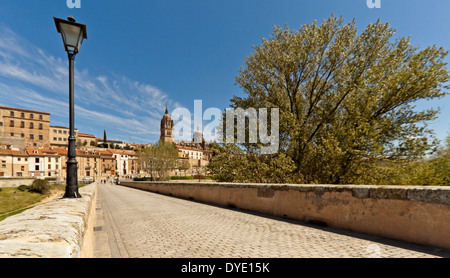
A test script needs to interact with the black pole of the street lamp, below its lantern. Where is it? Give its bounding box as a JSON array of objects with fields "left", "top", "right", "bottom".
[{"left": 64, "top": 52, "right": 81, "bottom": 198}]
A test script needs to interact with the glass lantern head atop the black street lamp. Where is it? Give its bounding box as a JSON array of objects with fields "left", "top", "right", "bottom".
[{"left": 53, "top": 17, "right": 87, "bottom": 54}]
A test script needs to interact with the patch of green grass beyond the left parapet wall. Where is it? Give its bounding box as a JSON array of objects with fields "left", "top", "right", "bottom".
[{"left": 0, "top": 185, "right": 65, "bottom": 221}]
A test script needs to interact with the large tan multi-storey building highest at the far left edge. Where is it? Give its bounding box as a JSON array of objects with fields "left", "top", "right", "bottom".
[{"left": 0, "top": 106, "right": 50, "bottom": 149}]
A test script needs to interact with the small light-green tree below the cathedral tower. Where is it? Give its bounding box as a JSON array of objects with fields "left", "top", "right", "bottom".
[{"left": 139, "top": 141, "right": 178, "bottom": 180}]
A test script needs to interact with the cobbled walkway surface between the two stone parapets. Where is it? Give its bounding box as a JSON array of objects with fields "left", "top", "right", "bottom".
[{"left": 94, "top": 184, "right": 450, "bottom": 258}]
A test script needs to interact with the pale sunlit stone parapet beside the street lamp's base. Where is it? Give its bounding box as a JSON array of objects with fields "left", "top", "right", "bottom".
[{"left": 0, "top": 183, "right": 97, "bottom": 258}]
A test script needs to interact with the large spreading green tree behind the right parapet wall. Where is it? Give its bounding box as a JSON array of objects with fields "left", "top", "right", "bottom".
[{"left": 222, "top": 15, "right": 450, "bottom": 183}]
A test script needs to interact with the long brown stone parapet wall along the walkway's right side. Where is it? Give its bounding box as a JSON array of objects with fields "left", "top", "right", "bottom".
[{"left": 121, "top": 182, "right": 450, "bottom": 249}]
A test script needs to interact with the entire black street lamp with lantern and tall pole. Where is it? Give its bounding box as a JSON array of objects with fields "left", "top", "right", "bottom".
[{"left": 53, "top": 16, "right": 87, "bottom": 198}]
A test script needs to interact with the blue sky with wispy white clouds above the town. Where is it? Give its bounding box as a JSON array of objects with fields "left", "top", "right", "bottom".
[{"left": 0, "top": 0, "right": 450, "bottom": 146}]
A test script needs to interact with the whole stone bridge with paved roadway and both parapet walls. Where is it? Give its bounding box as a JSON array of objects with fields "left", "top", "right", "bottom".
[{"left": 0, "top": 182, "right": 450, "bottom": 258}]
